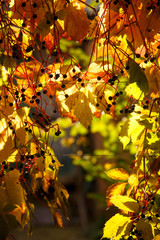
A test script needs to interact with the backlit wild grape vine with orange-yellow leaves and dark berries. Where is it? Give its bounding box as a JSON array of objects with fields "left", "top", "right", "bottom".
[{"left": 0, "top": 0, "right": 160, "bottom": 240}]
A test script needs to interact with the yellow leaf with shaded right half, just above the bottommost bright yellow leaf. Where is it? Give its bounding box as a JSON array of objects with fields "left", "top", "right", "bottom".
[{"left": 110, "top": 195, "right": 139, "bottom": 212}]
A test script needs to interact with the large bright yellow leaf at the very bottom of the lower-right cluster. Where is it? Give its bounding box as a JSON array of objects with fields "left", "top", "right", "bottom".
[{"left": 102, "top": 213, "right": 131, "bottom": 240}]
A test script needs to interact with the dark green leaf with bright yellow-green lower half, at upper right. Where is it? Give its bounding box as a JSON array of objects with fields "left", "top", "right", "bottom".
[{"left": 125, "top": 60, "right": 149, "bottom": 100}]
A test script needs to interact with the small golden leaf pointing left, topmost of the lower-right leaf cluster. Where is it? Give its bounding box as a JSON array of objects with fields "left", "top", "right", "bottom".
[{"left": 105, "top": 168, "right": 129, "bottom": 180}]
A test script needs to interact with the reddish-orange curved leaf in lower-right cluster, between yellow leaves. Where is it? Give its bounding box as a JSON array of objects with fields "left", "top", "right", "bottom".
[{"left": 106, "top": 183, "right": 127, "bottom": 207}]
